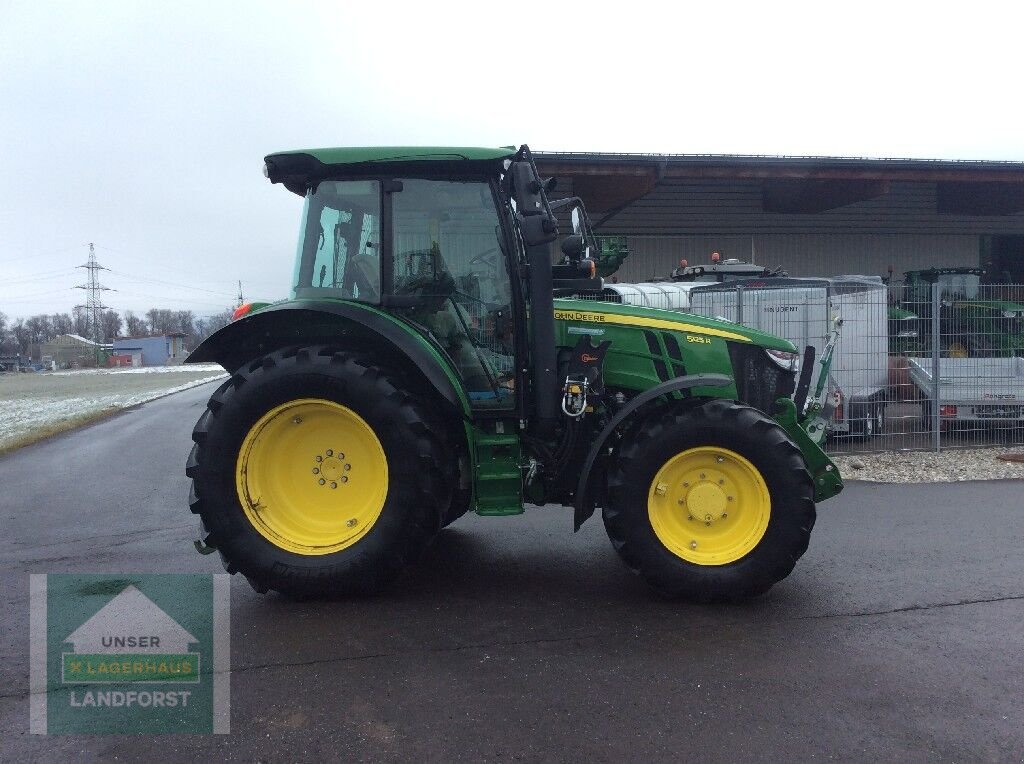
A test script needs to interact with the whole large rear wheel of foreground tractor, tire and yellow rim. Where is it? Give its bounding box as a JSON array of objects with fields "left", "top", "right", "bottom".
[{"left": 186, "top": 347, "right": 455, "bottom": 596}]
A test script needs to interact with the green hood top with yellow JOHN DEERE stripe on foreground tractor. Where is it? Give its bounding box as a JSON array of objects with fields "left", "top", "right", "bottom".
[{"left": 555, "top": 299, "right": 797, "bottom": 352}]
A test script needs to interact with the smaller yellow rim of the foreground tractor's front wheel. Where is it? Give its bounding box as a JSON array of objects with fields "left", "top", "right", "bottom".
[{"left": 647, "top": 445, "right": 771, "bottom": 565}]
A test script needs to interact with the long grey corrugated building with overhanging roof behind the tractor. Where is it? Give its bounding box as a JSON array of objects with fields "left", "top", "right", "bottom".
[{"left": 538, "top": 153, "right": 1024, "bottom": 283}]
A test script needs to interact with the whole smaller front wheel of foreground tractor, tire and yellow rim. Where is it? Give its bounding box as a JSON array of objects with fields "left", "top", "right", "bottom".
[{"left": 603, "top": 400, "right": 815, "bottom": 602}]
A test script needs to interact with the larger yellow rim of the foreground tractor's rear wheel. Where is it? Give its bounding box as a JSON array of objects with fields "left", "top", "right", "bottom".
[{"left": 236, "top": 398, "right": 388, "bottom": 555}]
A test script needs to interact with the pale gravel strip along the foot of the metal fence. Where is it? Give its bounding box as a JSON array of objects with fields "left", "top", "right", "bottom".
[{"left": 833, "top": 445, "right": 1024, "bottom": 482}]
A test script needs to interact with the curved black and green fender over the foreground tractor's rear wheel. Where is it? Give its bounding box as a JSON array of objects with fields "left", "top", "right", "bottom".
[{"left": 185, "top": 300, "right": 469, "bottom": 418}]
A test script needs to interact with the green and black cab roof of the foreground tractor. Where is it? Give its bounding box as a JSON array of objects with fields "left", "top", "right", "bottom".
[{"left": 265, "top": 145, "right": 518, "bottom": 195}]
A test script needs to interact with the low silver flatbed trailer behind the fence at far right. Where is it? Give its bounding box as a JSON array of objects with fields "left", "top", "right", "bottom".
[{"left": 907, "top": 355, "right": 1024, "bottom": 427}]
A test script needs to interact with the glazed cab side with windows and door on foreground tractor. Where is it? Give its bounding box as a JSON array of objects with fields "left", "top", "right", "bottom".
[{"left": 292, "top": 174, "right": 521, "bottom": 409}]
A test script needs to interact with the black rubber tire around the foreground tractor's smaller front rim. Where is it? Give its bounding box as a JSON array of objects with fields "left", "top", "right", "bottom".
[{"left": 603, "top": 400, "right": 815, "bottom": 602}]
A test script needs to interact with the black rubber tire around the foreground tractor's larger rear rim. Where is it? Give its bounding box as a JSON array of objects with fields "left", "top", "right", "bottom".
[{"left": 185, "top": 346, "right": 457, "bottom": 597}]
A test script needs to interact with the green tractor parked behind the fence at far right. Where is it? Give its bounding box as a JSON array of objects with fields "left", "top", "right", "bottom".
[{"left": 900, "top": 267, "right": 1024, "bottom": 357}]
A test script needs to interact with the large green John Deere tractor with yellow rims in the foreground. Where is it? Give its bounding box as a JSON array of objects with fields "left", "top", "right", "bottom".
[{"left": 186, "top": 146, "right": 843, "bottom": 601}]
